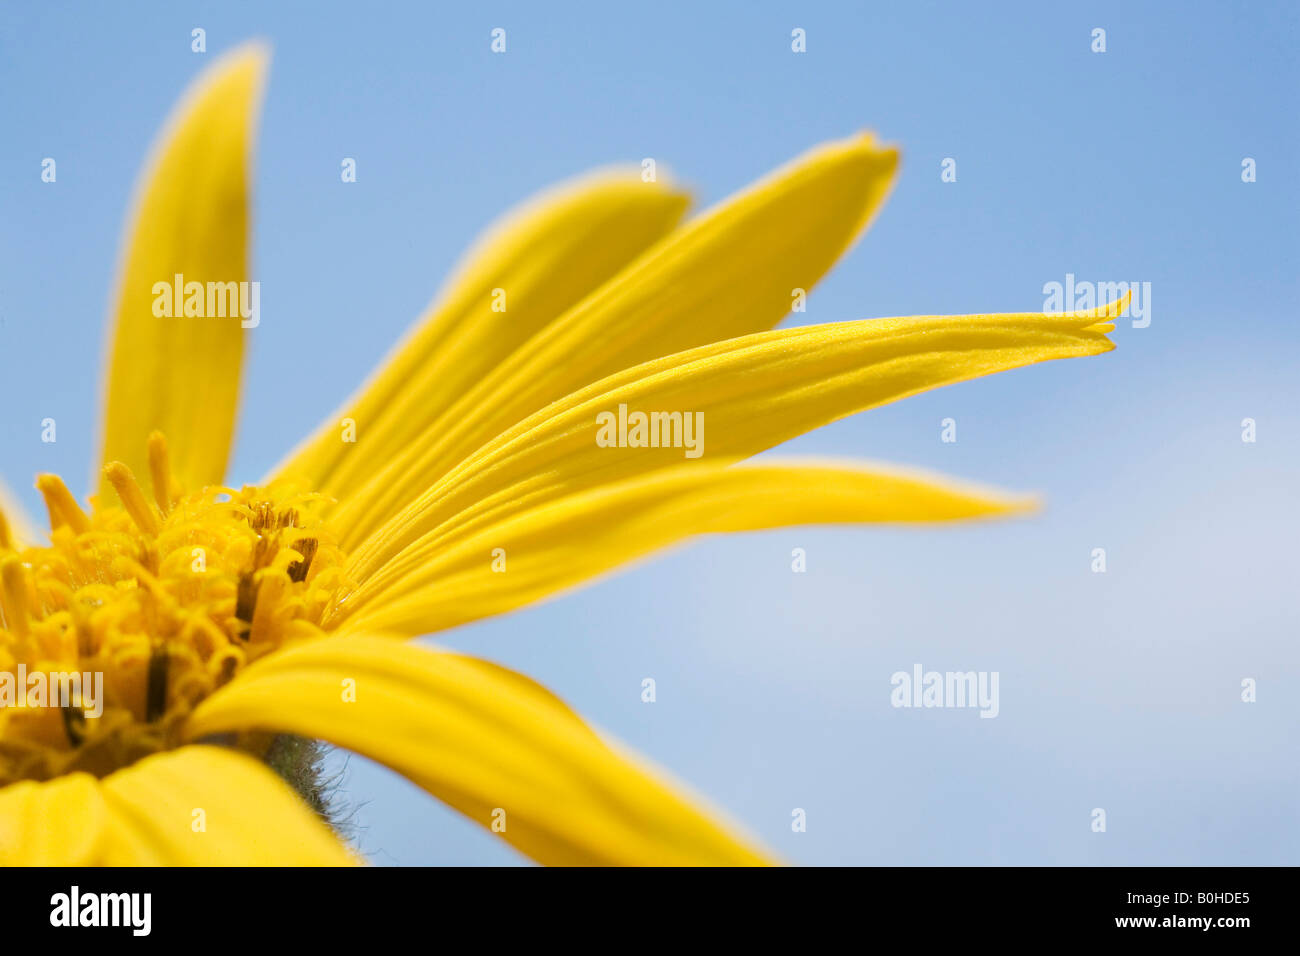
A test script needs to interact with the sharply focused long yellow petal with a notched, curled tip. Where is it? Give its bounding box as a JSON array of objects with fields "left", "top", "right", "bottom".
[{"left": 348, "top": 303, "right": 1114, "bottom": 592}]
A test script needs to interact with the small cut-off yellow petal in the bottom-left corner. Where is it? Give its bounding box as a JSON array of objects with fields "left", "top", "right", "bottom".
[{"left": 0, "top": 774, "right": 109, "bottom": 866}]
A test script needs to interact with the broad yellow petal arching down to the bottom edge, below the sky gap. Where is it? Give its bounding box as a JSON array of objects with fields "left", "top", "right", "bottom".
[{"left": 187, "top": 636, "right": 764, "bottom": 865}]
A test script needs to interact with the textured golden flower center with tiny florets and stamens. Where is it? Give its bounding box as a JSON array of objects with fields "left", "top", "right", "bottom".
[{"left": 0, "top": 434, "right": 343, "bottom": 786}]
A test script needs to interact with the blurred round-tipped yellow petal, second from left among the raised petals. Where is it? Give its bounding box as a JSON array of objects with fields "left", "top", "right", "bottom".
[{"left": 277, "top": 168, "right": 689, "bottom": 497}]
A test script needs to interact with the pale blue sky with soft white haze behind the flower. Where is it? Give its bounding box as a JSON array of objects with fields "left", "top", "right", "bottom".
[{"left": 0, "top": 0, "right": 1300, "bottom": 865}]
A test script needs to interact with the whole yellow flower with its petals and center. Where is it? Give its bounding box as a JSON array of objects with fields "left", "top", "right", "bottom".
[{"left": 0, "top": 46, "right": 1118, "bottom": 865}]
